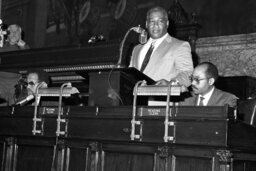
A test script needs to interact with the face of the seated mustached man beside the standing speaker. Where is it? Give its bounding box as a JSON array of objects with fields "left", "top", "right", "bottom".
[{"left": 191, "top": 66, "right": 213, "bottom": 95}]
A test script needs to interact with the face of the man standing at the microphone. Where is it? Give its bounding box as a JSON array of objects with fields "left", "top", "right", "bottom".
[{"left": 146, "top": 11, "right": 169, "bottom": 39}]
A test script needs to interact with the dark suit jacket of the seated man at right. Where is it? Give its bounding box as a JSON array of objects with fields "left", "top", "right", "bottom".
[{"left": 181, "top": 88, "right": 238, "bottom": 107}]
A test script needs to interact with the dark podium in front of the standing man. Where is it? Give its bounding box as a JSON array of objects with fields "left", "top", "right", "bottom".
[{"left": 78, "top": 68, "right": 154, "bottom": 106}]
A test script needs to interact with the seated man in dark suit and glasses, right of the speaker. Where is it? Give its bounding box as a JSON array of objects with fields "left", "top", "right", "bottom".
[{"left": 181, "top": 62, "right": 238, "bottom": 107}]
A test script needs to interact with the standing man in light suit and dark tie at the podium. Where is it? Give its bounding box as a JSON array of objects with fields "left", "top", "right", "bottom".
[{"left": 130, "top": 7, "right": 193, "bottom": 87}]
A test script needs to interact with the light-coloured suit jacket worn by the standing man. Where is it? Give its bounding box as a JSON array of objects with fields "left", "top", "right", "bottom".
[{"left": 129, "top": 35, "right": 193, "bottom": 86}]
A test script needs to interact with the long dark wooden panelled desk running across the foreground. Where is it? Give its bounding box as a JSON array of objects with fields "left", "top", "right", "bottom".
[{"left": 0, "top": 106, "right": 256, "bottom": 171}]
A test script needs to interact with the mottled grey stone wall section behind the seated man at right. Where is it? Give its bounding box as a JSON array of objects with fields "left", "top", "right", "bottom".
[{"left": 197, "top": 33, "right": 256, "bottom": 77}]
